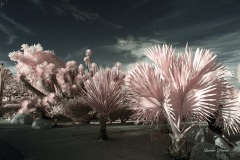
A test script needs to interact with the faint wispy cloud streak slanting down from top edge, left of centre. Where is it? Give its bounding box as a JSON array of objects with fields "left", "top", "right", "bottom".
[{"left": 29, "top": 0, "right": 122, "bottom": 29}]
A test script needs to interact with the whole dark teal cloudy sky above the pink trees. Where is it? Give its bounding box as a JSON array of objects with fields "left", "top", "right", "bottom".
[{"left": 0, "top": 0, "right": 240, "bottom": 88}]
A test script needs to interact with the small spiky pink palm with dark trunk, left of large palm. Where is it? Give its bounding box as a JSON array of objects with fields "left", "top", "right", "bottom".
[{"left": 83, "top": 68, "right": 125, "bottom": 140}]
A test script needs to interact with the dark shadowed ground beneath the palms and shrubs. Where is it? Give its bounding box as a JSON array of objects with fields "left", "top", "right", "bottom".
[{"left": 0, "top": 121, "right": 240, "bottom": 160}]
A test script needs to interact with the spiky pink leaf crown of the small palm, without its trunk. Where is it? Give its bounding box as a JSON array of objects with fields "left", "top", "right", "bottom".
[{"left": 84, "top": 68, "right": 125, "bottom": 115}]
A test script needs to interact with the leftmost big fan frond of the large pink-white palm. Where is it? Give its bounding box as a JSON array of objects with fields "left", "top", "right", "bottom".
[{"left": 126, "top": 63, "right": 174, "bottom": 123}]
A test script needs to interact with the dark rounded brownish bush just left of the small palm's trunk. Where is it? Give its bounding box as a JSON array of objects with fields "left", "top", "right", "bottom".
[{"left": 61, "top": 98, "right": 92, "bottom": 124}]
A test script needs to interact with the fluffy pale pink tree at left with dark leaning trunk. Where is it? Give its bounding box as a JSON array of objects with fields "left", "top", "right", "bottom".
[{"left": 9, "top": 44, "right": 65, "bottom": 97}]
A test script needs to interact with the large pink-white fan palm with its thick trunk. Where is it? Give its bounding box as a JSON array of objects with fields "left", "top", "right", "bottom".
[{"left": 126, "top": 45, "right": 240, "bottom": 159}]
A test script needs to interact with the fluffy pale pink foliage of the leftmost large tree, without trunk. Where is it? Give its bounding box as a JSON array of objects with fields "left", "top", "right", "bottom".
[{"left": 9, "top": 44, "right": 65, "bottom": 92}]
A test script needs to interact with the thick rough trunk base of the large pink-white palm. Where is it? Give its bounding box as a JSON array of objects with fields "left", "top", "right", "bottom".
[{"left": 169, "top": 134, "right": 190, "bottom": 160}]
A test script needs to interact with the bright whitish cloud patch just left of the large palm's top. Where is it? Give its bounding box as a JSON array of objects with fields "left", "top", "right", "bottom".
[{"left": 96, "top": 35, "right": 165, "bottom": 71}]
